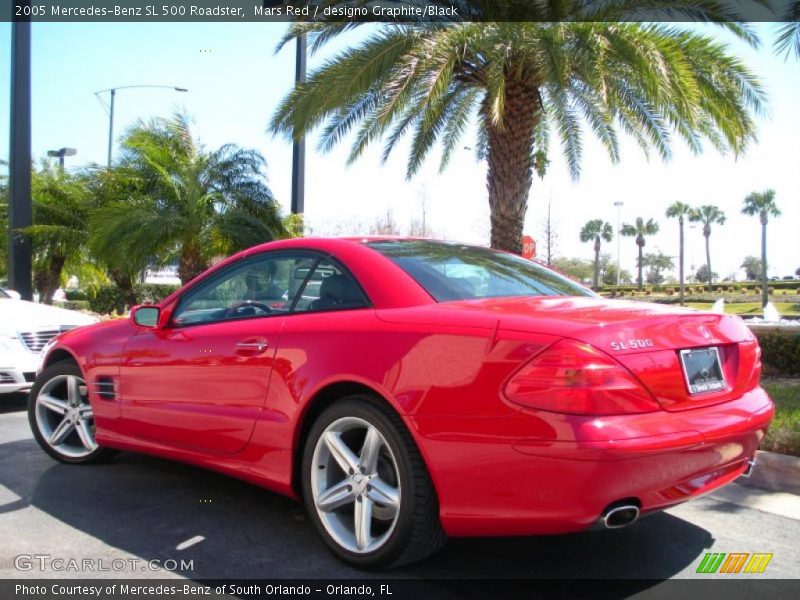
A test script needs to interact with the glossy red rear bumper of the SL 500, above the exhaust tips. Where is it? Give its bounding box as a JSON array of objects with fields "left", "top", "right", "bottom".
[{"left": 422, "top": 388, "right": 774, "bottom": 536}]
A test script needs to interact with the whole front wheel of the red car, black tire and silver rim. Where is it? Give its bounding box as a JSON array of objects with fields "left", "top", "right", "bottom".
[{"left": 28, "top": 361, "right": 113, "bottom": 464}]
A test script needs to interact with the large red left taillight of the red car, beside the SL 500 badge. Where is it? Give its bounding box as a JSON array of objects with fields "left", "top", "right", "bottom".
[{"left": 504, "top": 340, "right": 659, "bottom": 415}]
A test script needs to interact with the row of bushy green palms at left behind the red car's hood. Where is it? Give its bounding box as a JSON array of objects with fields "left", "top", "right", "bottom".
[{"left": 0, "top": 114, "right": 288, "bottom": 305}]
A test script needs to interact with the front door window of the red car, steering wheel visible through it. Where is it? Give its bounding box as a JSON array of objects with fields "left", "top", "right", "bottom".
[{"left": 172, "top": 252, "right": 319, "bottom": 326}]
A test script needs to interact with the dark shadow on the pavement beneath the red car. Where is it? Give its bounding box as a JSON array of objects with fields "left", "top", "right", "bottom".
[{"left": 0, "top": 439, "right": 713, "bottom": 587}]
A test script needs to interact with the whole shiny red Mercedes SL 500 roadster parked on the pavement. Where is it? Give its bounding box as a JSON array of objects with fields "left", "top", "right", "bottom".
[{"left": 29, "top": 238, "right": 773, "bottom": 568}]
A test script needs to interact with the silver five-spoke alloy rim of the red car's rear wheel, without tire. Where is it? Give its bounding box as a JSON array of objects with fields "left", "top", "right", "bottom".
[{"left": 310, "top": 417, "right": 401, "bottom": 554}]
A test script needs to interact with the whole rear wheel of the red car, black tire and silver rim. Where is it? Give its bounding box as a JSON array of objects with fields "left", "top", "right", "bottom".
[{"left": 302, "top": 396, "right": 445, "bottom": 569}]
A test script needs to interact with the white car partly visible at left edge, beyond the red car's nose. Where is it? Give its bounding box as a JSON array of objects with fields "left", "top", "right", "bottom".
[{"left": 0, "top": 289, "right": 97, "bottom": 394}]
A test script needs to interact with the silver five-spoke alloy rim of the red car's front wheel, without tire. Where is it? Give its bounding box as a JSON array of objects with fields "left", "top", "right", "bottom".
[{"left": 36, "top": 375, "right": 97, "bottom": 458}]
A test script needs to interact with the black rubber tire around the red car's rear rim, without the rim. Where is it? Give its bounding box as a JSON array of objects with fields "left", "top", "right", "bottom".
[{"left": 302, "top": 395, "right": 447, "bottom": 569}]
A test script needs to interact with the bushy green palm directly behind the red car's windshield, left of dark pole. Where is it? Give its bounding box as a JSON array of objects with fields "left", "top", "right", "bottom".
[{"left": 92, "top": 114, "right": 286, "bottom": 283}]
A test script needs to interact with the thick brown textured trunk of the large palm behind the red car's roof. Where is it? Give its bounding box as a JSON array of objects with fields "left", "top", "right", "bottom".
[{"left": 483, "top": 79, "right": 540, "bottom": 254}]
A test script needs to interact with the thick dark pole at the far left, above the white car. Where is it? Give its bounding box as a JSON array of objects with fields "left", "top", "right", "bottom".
[{"left": 8, "top": 11, "right": 33, "bottom": 300}]
